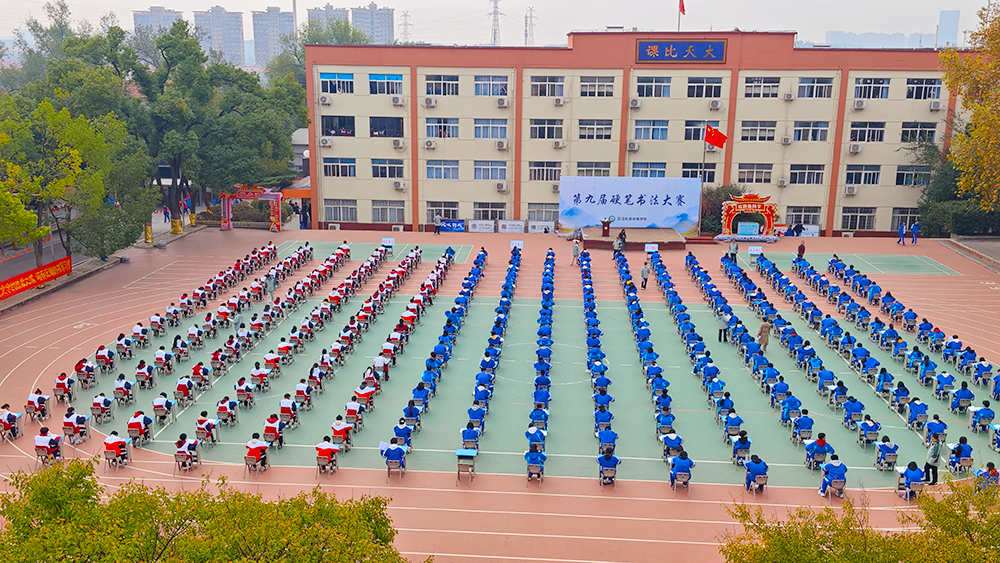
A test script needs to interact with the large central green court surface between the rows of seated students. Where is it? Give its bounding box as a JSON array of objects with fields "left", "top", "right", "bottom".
[{"left": 83, "top": 240, "right": 1000, "bottom": 488}]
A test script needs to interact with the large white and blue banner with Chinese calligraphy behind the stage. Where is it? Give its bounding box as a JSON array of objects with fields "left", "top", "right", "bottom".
[{"left": 559, "top": 176, "right": 701, "bottom": 235}]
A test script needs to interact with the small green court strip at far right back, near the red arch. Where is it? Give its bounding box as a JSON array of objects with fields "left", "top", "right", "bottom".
[{"left": 739, "top": 252, "right": 962, "bottom": 276}]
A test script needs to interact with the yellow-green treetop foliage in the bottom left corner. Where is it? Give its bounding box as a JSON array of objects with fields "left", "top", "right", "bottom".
[{"left": 0, "top": 460, "right": 414, "bottom": 563}]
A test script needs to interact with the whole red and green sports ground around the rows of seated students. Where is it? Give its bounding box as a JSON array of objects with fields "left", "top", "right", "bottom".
[{"left": 0, "top": 230, "right": 1000, "bottom": 562}]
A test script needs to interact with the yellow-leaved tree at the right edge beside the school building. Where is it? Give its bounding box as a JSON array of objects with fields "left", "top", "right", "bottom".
[{"left": 941, "top": 4, "right": 1000, "bottom": 211}]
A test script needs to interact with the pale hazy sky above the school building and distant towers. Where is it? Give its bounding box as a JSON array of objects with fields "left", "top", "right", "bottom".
[{"left": 0, "top": 0, "right": 985, "bottom": 46}]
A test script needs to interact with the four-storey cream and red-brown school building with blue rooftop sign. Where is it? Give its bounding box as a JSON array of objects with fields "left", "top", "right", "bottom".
[{"left": 306, "top": 31, "right": 956, "bottom": 236}]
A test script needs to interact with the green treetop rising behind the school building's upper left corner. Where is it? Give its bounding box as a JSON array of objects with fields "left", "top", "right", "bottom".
[{"left": 264, "top": 19, "right": 371, "bottom": 88}]
